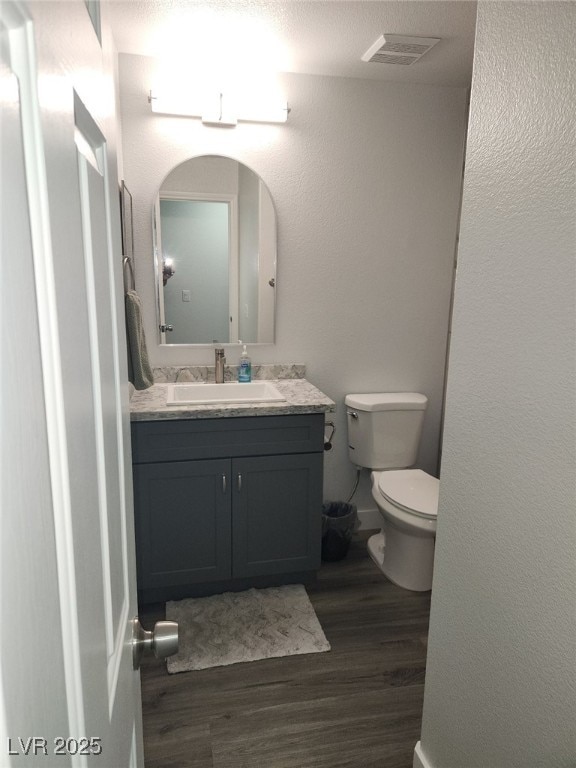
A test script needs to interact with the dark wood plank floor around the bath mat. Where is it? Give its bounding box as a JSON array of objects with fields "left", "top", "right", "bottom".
[{"left": 141, "top": 535, "right": 430, "bottom": 768}]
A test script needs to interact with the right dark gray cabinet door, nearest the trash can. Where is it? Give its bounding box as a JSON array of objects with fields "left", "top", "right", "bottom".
[{"left": 232, "top": 453, "right": 323, "bottom": 577}]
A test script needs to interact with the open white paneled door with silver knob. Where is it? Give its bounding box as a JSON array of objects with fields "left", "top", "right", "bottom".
[{"left": 0, "top": 0, "right": 158, "bottom": 768}]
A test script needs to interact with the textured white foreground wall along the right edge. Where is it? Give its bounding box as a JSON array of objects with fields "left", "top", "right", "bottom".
[{"left": 415, "top": 0, "right": 576, "bottom": 768}]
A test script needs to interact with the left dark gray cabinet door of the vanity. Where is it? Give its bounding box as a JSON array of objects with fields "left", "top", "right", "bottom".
[{"left": 134, "top": 459, "right": 231, "bottom": 589}]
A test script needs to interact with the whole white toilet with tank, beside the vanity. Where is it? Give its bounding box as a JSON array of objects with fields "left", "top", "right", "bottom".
[{"left": 344, "top": 392, "right": 439, "bottom": 592}]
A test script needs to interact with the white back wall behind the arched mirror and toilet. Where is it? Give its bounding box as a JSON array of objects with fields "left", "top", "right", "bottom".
[{"left": 120, "top": 55, "right": 466, "bottom": 505}]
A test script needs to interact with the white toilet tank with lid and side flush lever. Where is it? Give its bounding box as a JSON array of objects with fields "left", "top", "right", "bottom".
[{"left": 344, "top": 392, "right": 428, "bottom": 469}]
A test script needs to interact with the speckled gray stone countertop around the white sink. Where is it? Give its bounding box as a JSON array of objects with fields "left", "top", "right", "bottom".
[{"left": 130, "top": 378, "right": 336, "bottom": 421}]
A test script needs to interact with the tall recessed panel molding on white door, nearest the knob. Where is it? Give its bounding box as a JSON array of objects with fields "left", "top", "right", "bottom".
[{"left": 74, "top": 93, "right": 130, "bottom": 717}]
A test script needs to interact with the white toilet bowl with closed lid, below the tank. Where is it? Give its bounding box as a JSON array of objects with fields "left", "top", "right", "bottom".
[{"left": 368, "top": 469, "right": 440, "bottom": 592}]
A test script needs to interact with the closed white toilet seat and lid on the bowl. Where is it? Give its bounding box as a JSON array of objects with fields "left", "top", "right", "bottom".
[{"left": 378, "top": 469, "right": 440, "bottom": 520}]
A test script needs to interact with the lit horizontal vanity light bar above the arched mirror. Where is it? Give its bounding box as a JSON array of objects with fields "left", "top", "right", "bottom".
[{"left": 148, "top": 91, "right": 290, "bottom": 127}]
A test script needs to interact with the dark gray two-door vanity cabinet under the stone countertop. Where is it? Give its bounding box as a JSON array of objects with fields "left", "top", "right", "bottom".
[{"left": 132, "top": 414, "right": 324, "bottom": 602}]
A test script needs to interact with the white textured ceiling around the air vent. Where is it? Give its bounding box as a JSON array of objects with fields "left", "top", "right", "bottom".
[{"left": 106, "top": 0, "right": 476, "bottom": 86}]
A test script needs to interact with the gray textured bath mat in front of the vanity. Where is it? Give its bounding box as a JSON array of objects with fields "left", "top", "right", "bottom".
[{"left": 166, "top": 584, "right": 330, "bottom": 674}]
